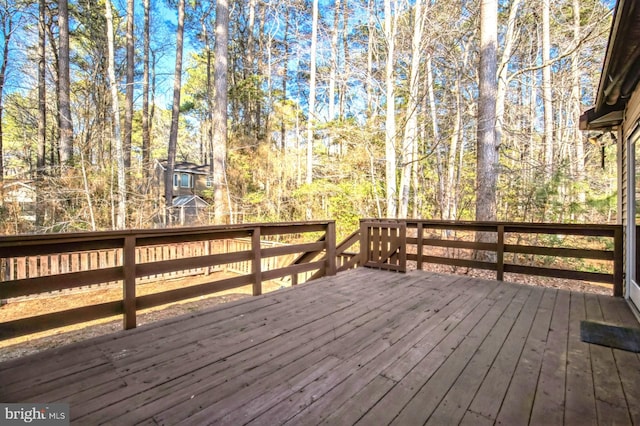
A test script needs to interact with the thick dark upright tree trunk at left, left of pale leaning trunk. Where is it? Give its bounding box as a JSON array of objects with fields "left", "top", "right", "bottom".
[{"left": 58, "top": 0, "right": 73, "bottom": 168}]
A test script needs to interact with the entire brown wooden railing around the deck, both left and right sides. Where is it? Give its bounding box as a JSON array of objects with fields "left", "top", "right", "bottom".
[{"left": 0, "top": 219, "right": 623, "bottom": 339}]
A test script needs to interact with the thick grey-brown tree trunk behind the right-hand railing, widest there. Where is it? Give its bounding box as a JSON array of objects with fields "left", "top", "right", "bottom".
[{"left": 476, "top": 0, "right": 498, "bottom": 225}]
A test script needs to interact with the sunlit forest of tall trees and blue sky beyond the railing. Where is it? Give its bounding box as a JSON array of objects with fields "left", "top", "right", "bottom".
[{"left": 0, "top": 0, "right": 616, "bottom": 233}]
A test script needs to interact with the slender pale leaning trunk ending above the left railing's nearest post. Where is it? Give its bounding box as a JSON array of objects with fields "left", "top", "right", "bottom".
[{"left": 105, "top": 1, "right": 127, "bottom": 229}]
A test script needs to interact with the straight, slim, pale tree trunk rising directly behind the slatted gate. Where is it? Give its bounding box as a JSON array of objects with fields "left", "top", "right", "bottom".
[{"left": 384, "top": 0, "right": 397, "bottom": 218}]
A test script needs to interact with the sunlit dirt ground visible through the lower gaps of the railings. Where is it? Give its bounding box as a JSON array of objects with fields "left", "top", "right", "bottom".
[{"left": 0, "top": 265, "right": 612, "bottom": 362}]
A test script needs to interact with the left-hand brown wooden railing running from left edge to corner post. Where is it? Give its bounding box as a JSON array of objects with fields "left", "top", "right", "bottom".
[{"left": 0, "top": 221, "right": 336, "bottom": 339}]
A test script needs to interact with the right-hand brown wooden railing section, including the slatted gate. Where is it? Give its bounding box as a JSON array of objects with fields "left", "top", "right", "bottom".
[{"left": 361, "top": 219, "right": 624, "bottom": 296}]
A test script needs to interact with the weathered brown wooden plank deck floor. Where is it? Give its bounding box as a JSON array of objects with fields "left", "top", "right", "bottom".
[{"left": 0, "top": 268, "right": 640, "bottom": 425}]
